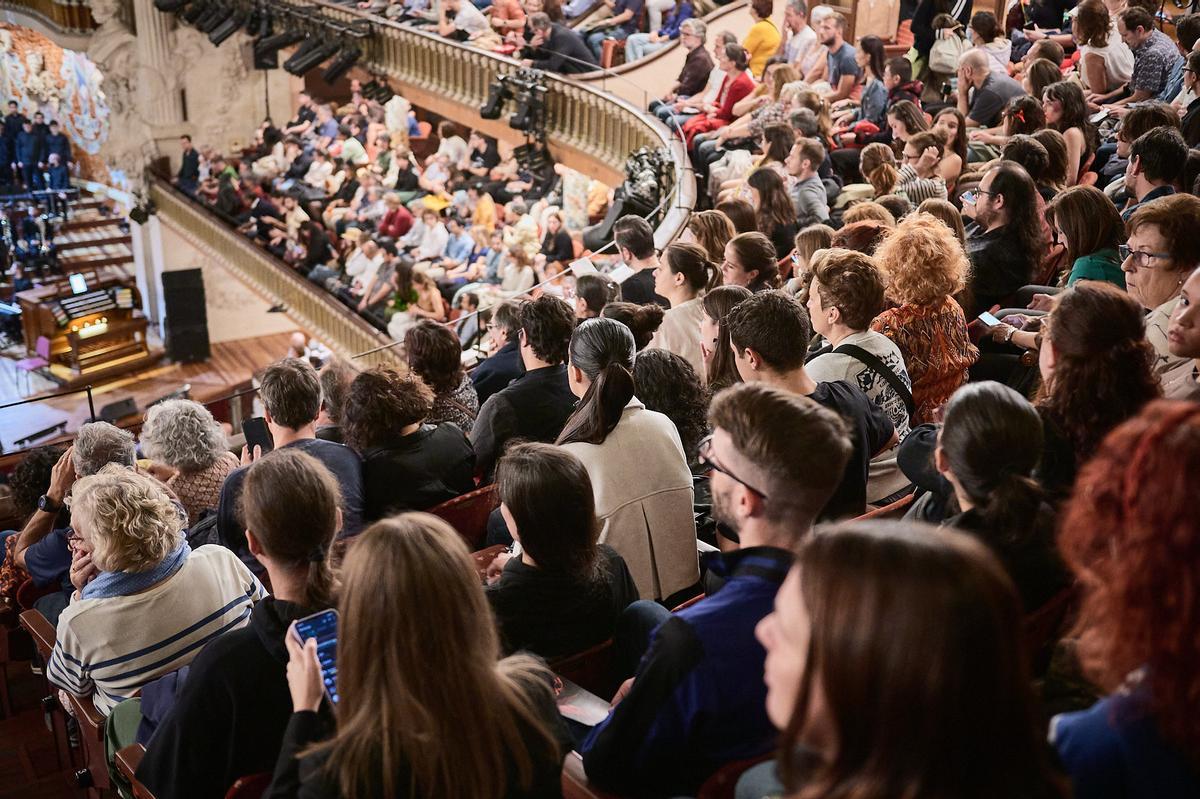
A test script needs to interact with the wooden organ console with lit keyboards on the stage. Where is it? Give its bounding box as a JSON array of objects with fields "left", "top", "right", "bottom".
[{"left": 16, "top": 281, "right": 150, "bottom": 376}]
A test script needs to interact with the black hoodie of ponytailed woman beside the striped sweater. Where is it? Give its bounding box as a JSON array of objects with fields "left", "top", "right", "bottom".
[{"left": 137, "top": 596, "right": 328, "bottom": 799}]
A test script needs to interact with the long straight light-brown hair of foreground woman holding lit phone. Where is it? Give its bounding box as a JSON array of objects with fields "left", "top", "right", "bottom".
[{"left": 313, "top": 513, "right": 562, "bottom": 799}]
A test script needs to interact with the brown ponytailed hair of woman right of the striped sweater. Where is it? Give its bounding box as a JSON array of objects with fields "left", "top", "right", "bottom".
[{"left": 241, "top": 447, "right": 342, "bottom": 611}]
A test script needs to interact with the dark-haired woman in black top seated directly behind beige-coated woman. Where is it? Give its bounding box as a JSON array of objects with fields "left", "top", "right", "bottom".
[{"left": 487, "top": 444, "right": 638, "bottom": 657}]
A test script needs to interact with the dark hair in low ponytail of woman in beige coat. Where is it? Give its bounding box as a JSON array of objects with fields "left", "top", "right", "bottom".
[{"left": 554, "top": 318, "right": 637, "bottom": 444}]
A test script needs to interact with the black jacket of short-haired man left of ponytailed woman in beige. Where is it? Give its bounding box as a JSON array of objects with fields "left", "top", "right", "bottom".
[{"left": 470, "top": 364, "right": 576, "bottom": 476}]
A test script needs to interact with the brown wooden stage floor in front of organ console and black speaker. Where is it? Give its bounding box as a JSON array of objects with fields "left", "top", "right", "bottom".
[{"left": 0, "top": 332, "right": 292, "bottom": 451}]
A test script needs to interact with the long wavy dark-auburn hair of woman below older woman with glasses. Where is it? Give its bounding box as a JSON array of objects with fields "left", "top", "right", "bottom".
[{"left": 1034, "top": 282, "right": 1163, "bottom": 463}]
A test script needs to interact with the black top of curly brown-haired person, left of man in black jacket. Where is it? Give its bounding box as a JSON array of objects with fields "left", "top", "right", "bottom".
[{"left": 362, "top": 422, "right": 475, "bottom": 522}]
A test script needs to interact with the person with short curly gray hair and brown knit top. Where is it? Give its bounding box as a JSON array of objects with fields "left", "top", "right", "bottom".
[{"left": 142, "top": 400, "right": 239, "bottom": 525}]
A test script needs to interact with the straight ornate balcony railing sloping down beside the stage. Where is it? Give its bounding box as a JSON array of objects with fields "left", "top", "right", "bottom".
[{"left": 150, "top": 176, "right": 401, "bottom": 366}]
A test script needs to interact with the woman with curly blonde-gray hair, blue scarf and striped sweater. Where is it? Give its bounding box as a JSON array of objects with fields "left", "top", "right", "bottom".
[{"left": 46, "top": 464, "right": 266, "bottom": 715}]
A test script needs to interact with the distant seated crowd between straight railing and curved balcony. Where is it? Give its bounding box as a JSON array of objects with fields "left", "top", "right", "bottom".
[{"left": 175, "top": 82, "right": 610, "bottom": 348}]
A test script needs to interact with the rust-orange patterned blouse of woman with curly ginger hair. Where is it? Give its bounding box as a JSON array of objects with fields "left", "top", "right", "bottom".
[{"left": 871, "top": 296, "right": 979, "bottom": 426}]
